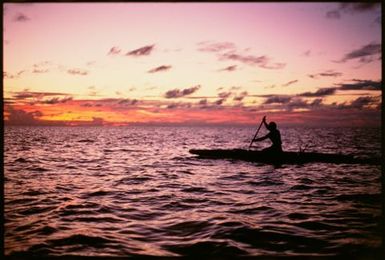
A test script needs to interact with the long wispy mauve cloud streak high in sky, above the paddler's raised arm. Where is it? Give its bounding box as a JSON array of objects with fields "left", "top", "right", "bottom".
[{"left": 219, "top": 52, "right": 286, "bottom": 69}]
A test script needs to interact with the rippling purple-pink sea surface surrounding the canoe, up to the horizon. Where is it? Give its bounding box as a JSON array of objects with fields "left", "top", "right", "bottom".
[{"left": 4, "top": 126, "right": 383, "bottom": 259}]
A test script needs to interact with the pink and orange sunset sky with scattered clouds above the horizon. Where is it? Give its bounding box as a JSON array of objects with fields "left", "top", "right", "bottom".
[{"left": 3, "top": 3, "right": 382, "bottom": 127}]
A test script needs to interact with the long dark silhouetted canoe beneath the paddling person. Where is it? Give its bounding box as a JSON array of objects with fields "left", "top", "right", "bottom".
[{"left": 189, "top": 149, "right": 381, "bottom": 165}]
